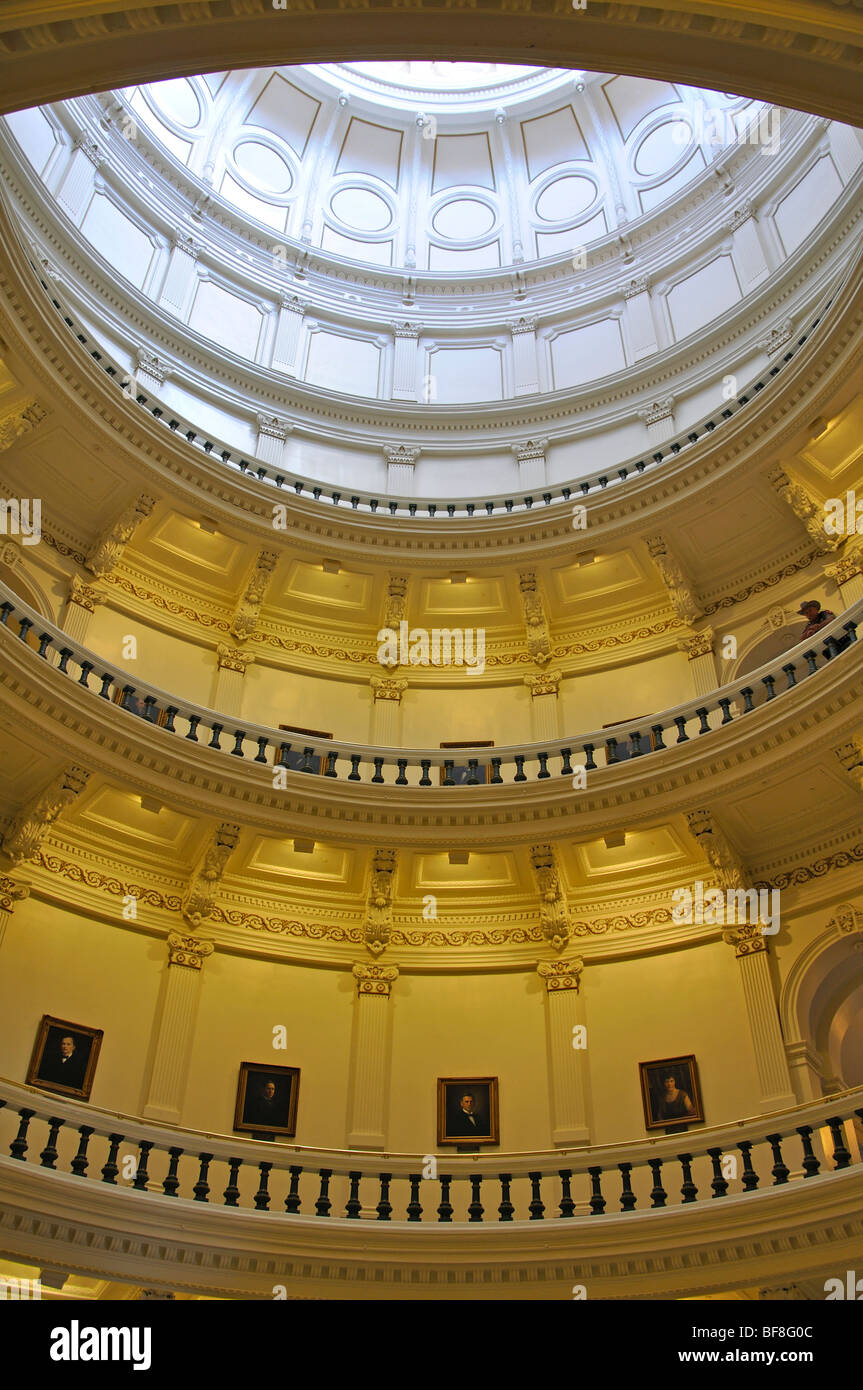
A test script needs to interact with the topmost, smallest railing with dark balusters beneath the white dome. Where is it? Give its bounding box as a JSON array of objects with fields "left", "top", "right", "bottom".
[{"left": 31, "top": 261, "right": 835, "bottom": 520}]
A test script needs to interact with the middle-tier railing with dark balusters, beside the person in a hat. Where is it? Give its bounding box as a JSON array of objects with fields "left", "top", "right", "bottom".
[{"left": 0, "top": 584, "right": 863, "bottom": 787}]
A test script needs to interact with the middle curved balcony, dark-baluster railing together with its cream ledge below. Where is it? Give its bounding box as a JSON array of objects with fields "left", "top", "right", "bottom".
[{"left": 0, "top": 588, "right": 863, "bottom": 848}]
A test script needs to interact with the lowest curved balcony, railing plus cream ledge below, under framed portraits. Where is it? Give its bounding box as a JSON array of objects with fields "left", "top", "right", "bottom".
[{"left": 0, "top": 1083, "right": 863, "bottom": 1300}]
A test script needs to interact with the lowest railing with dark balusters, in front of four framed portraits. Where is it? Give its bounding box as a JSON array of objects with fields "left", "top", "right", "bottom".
[{"left": 0, "top": 1080, "right": 863, "bottom": 1225}]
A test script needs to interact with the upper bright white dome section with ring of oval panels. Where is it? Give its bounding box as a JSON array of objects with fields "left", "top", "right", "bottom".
[{"left": 124, "top": 63, "right": 757, "bottom": 275}]
